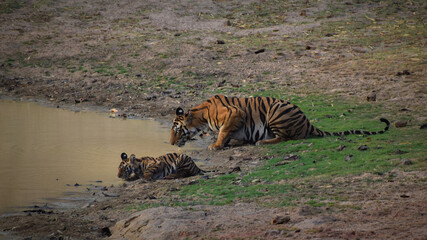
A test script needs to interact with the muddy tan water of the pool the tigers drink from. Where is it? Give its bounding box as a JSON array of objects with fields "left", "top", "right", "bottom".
[{"left": 0, "top": 100, "right": 197, "bottom": 212}]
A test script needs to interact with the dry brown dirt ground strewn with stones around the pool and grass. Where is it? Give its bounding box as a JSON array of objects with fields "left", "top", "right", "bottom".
[{"left": 0, "top": 0, "right": 427, "bottom": 239}]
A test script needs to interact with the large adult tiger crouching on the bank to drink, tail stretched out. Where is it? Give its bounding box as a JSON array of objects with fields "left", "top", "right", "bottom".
[{"left": 170, "top": 95, "right": 390, "bottom": 150}]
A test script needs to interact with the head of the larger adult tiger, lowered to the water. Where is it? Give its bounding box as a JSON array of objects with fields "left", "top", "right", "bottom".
[{"left": 170, "top": 107, "right": 191, "bottom": 147}]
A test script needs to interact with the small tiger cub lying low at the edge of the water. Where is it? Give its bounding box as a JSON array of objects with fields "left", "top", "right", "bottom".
[{"left": 117, "top": 153, "right": 205, "bottom": 181}]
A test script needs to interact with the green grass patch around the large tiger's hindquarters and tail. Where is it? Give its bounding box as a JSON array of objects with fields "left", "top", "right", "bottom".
[{"left": 135, "top": 92, "right": 427, "bottom": 209}]
